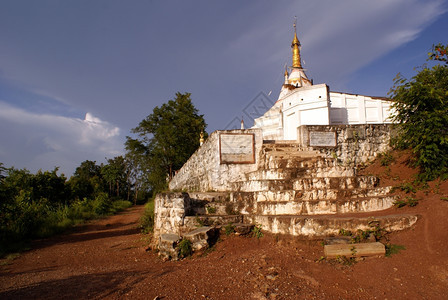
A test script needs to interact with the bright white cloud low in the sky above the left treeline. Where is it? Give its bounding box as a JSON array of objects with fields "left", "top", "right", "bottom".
[{"left": 0, "top": 101, "right": 123, "bottom": 176}]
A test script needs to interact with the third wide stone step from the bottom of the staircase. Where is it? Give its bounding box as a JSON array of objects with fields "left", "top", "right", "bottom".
[{"left": 230, "top": 187, "right": 392, "bottom": 202}]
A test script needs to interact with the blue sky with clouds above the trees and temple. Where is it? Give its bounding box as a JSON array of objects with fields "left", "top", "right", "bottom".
[{"left": 0, "top": 0, "right": 448, "bottom": 176}]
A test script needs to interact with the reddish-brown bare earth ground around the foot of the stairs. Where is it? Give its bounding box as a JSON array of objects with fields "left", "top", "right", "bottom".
[{"left": 0, "top": 151, "right": 448, "bottom": 299}]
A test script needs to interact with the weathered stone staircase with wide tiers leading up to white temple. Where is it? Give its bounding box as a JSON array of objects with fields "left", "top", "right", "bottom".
[{"left": 156, "top": 142, "right": 417, "bottom": 258}]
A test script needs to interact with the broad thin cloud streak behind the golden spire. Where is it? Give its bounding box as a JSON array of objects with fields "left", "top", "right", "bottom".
[{"left": 228, "top": 0, "right": 447, "bottom": 90}]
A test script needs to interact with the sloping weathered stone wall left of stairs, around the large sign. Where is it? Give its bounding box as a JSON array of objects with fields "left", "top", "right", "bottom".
[{"left": 169, "top": 129, "right": 263, "bottom": 191}]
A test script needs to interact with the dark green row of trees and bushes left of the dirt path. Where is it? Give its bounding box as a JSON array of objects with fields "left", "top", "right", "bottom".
[{"left": 0, "top": 156, "right": 147, "bottom": 256}]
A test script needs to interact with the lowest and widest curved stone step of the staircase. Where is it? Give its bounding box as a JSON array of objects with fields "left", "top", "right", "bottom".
[{"left": 244, "top": 214, "right": 418, "bottom": 238}]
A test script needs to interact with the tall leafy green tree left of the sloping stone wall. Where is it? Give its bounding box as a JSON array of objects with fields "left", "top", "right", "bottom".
[{"left": 126, "top": 93, "right": 207, "bottom": 191}]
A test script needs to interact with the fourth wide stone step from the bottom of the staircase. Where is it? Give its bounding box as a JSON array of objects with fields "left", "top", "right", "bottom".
[{"left": 232, "top": 176, "right": 379, "bottom": 192}]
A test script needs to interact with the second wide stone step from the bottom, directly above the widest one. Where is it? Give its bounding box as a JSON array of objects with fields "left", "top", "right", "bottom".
[{"left": 239, "top": 196, "right": 395, "bottom": 216}]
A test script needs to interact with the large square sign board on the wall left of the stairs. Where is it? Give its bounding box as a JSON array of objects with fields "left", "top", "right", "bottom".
[{"left": 219, "top": 133, "right": 255, "bottom": 164}]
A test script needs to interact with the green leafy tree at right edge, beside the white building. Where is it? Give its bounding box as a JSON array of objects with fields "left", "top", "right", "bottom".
[{"left": 390, "top": 45, "right": 448, "bottom": 180}]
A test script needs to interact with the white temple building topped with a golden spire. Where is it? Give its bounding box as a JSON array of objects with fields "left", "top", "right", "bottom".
[{"left": 252, "top": 24, "right": 391, "bottom": 140}]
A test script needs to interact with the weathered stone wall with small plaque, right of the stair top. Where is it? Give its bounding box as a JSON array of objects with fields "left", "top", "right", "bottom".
[{"left": 297, "top": 124, "right": 391, "bottom": 165}]
